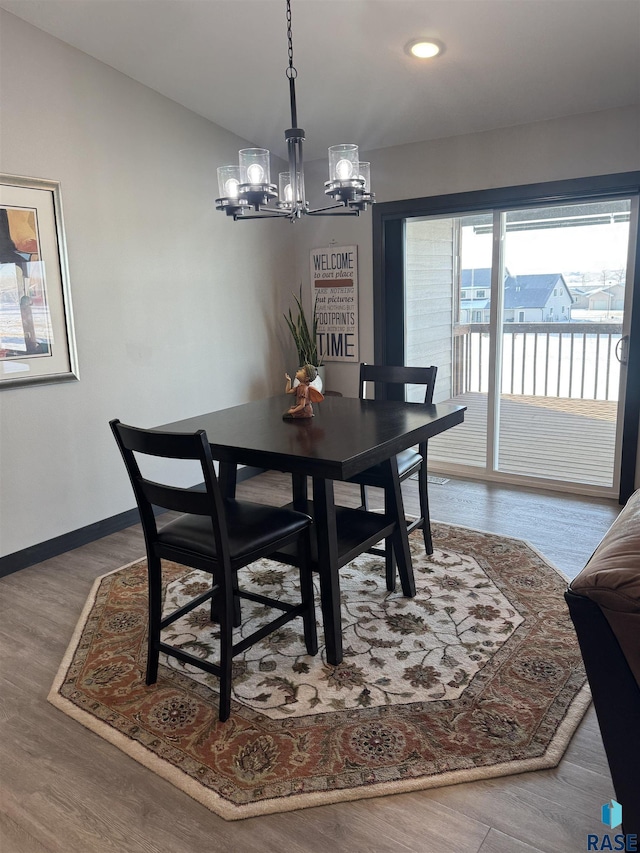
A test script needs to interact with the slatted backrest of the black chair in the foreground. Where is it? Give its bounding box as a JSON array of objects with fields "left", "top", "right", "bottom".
[{"left": 109, "top": 419, "right": 227, "bottom": 557}]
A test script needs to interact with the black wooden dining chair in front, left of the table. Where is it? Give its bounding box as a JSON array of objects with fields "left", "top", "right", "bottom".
[{"left": 110, "top": 419, "right": 318, "bottom": 721}]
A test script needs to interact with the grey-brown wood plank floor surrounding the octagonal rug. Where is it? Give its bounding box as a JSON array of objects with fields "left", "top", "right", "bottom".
[{"left": 0, "top": 473, "right": 619, "bottom": 853}]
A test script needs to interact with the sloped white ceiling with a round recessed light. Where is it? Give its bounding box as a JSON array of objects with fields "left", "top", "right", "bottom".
[{"left": 0, "top": 0, "right": 640, "bottom": 158}]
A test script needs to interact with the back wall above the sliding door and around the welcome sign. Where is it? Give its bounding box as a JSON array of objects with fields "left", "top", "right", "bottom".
[{"left": 296, "top": 106, "right": 640, "bottom": 395}]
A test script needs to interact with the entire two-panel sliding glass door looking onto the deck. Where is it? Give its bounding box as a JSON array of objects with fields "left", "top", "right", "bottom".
[{"left": 376, "top": 177, "right": 638, "bottom": 496}]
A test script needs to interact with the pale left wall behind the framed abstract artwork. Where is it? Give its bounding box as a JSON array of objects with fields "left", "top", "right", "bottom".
[{"left": 0, "top": 10, "right": 297, "bottom": 556}]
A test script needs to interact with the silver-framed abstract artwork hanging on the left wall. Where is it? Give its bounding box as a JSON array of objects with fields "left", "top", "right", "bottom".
[{"left": 0, "top": 174, "right": 79, "bottom": 390}]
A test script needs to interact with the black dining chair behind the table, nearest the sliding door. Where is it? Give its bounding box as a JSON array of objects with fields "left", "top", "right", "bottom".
[{"left": 349, "top": 362, "right": 438, "bottom": 590}]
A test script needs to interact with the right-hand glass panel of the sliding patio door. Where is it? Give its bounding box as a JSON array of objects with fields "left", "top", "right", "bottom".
[{"left": 495, "top": 199, "right": 633, "bottom": 493}]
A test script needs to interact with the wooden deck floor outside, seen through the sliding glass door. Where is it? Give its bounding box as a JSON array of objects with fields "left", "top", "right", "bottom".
[{"left": 429, "top": 393, "right": 617, "bottom": 487}]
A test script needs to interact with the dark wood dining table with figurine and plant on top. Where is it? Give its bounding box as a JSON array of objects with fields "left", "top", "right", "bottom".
[{"left": 157, "top": 395, "right": 466, "bottom": 665}]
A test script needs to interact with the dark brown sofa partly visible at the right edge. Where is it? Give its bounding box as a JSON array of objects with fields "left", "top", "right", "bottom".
[{"left": 565, "top": 490, "right": 640, "bottom": 837}]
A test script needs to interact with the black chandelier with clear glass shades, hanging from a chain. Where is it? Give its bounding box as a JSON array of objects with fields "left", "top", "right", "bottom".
[{"left": 216, "top": 0, "right": 375, "bottom": 222}]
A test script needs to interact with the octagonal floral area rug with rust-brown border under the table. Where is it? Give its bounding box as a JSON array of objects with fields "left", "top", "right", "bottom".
[{"left": 49, "top": 524, "right": 590, "bottom": 820}]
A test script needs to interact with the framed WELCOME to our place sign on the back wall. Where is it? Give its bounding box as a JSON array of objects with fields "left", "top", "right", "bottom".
[{"left": 311, "top": 246, "right": 360, "bottom": 362}]
